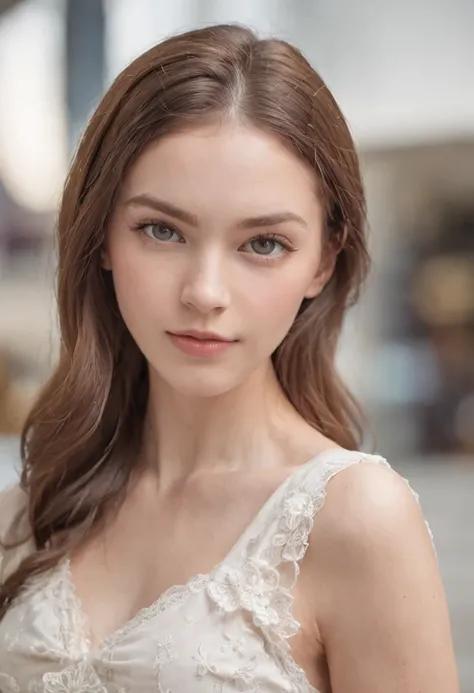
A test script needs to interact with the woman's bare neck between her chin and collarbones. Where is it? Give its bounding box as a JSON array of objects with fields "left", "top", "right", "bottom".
[{"left": 139, "top": 364, "right": 323, "bottom": 488}]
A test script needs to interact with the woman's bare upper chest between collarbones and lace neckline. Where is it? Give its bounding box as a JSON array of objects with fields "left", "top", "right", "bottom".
[{"left": 68, "top": 468, "right": 304, "bottom": 645}]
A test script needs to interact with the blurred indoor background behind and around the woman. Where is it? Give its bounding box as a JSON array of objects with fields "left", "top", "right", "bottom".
[{"left": 0, "top": 0, "right": 474, "bottom": 693}]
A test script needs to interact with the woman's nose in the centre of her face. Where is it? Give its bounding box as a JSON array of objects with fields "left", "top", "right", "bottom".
[{"left": 181, "top": 253, "right": 230, "bottom": 313}]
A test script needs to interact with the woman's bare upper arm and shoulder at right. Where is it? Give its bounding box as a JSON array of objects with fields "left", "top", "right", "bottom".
[{"left": 308, "top": 464, "right": 459, "bottom": 693}]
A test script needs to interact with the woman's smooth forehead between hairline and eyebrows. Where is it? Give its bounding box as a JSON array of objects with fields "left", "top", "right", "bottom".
[{"left": 121, "top": 125, "right": 319, "bottom": 222}]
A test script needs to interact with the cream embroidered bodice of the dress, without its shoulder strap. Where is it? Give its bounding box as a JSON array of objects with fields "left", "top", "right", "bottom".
[{"left": 0, "top": 556, "right": 326, "bottom": 693}]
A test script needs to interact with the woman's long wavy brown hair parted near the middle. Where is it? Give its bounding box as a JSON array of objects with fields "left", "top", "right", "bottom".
[{"left": 0, "top": 25, "right": 368, "bottom": 615}]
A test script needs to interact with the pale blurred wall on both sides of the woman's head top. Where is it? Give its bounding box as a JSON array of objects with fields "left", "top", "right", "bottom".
[{"left": 109, "top": 0, "right": 474, "bottom": 147}]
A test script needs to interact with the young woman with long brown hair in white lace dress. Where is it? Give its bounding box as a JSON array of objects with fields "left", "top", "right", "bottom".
[{"left": 0, "top": 21, "right": 457, "bottom": 693}]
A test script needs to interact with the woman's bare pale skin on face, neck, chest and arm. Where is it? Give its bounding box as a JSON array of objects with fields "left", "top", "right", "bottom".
[{"left": 66, "top": 124, "right": 458, "bottom": 693}]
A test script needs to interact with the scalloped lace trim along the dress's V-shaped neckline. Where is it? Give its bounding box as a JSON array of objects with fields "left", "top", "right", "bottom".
[{"left": 60, "top": 447, "right": 349, "bottom": 656}]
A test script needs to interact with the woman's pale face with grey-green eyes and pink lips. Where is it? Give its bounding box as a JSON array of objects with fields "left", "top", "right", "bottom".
[{"left": 103, "top": 125, "right": 328, "bottom": 397}]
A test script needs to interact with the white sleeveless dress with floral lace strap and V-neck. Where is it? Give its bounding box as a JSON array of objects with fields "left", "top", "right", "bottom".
[{"left": 0, "top": 450, "right": 430, "bottom": 693}]
